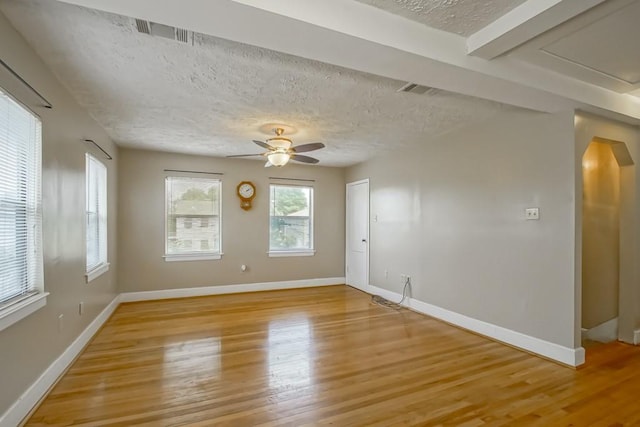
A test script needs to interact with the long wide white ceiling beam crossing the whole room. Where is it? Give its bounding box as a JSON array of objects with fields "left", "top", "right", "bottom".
[{"left": 56, "top": 0, "right": 640, "bottom": 119}]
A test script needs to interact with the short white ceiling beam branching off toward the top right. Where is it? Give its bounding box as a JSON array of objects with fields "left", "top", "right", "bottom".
[{"left": 467, "top": 0, "right": 606, "bottom": 59}]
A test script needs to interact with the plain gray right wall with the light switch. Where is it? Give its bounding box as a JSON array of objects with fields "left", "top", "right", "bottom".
[{"left": 346, "top": 112, "right": 576, "bottom": 348}]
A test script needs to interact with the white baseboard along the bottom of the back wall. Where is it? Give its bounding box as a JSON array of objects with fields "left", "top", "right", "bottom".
[{"left": 120, "top": 277, "right": 345, "bottom": 302}]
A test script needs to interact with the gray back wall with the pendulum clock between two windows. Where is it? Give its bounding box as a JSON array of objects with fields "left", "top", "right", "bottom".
[{"left": 118, "top": 149, "right": 345, "bottom": 292}]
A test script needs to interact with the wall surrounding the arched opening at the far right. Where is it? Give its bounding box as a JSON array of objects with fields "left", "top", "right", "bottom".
[{"left": 575, "top": 113, "right": 640, "bottom": 342}]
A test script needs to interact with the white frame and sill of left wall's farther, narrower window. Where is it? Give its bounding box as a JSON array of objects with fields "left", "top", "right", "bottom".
[{"left": 84, "top": 153, "right": 111, "bottom": 283}]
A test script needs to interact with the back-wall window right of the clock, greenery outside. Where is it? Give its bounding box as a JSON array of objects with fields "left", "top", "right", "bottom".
[{"left": 269, "top": 184, "right": 314, "bottom": 256}]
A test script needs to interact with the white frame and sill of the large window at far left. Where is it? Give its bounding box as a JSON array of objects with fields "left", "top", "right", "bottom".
[{"left": 0, "top": 87, "right": 49, "bottom": 331}]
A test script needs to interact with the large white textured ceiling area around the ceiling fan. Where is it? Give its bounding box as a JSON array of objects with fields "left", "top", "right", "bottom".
[{"left": 0, "top": 0, "right": 511, "bottom": 166}]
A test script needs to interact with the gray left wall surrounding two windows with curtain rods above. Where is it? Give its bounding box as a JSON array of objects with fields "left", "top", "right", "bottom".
[{"left": 0, "top": 14, "right": 118, "bottom": 414}]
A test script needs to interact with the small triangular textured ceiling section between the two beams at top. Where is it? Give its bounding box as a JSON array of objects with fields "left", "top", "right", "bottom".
[{"left": 357, "top": 0, "right": 526, "bottom": 36}]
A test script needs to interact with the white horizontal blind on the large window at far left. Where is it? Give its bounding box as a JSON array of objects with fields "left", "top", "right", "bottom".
[{"left": 0, "top": 90, "right": 42, "bottom": 310}]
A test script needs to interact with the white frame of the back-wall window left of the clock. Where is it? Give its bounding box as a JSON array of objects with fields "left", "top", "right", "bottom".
[{"left": 162, "top": 173, "right": 224, "bottom": 262}]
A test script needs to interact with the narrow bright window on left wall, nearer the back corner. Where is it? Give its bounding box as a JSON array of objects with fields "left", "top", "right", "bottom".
[{"left": 85, "top": 154, "right": 109, "bottom": 282}]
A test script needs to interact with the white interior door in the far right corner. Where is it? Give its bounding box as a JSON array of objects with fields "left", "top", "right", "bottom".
[{"left": 345, "top": 179, "right": 369, "bottom": 291}]
